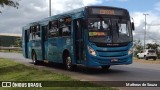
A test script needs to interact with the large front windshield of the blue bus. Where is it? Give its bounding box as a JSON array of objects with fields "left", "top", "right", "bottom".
[{"left": 88, "top": 17, "right": 132, "bottom": 43}]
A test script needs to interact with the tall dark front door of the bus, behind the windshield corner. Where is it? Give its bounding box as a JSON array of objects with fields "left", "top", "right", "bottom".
[{"left": 74, "top": 19, "right": 84, "bottom": 64}]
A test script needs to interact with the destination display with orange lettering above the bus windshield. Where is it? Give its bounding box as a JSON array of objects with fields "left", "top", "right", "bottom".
[{"left": 90, "top": 8, "right": 125, "bottom": 15}]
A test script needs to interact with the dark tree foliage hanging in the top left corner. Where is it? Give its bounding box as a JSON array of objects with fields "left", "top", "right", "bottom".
[{"left": 0, "top": 0, "right": 19, "bottom": 13}]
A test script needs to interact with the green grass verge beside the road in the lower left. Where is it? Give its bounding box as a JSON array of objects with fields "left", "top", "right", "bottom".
[{"left": 0, "top": 58, "right": 117, "bottom": 90}]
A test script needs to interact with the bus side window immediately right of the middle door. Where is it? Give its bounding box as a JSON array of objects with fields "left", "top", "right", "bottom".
[{"left": 48, "top": 20, "right": 59, "bottom": 38}]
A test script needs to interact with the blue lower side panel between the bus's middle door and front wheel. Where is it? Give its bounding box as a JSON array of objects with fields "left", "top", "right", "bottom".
[{"left": 46, "top": 37, "right": 72, "bottom": 63}]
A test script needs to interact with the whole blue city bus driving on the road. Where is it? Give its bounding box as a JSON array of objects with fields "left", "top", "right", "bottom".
[{"left": 22, "top": 6, "right": 134, "bottom": 70}]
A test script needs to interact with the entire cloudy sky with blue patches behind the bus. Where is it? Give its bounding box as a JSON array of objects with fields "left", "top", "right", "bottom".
[{"left": 0, "top": 0, "right": 160, "bottom": 43}]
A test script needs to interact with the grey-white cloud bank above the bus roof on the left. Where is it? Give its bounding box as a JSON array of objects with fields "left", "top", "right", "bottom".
[{"left": 0, "top": 0, "right": 102, "bottom": 34}]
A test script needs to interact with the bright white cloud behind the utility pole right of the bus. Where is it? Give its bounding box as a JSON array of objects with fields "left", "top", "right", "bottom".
[{"left": 131, "top": 11, "right": 160, "bottom": 42}]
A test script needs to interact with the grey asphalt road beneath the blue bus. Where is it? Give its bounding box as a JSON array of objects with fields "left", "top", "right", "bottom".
[{"left": 0, "top": 52, "right": 160, "bottom": 90}]
